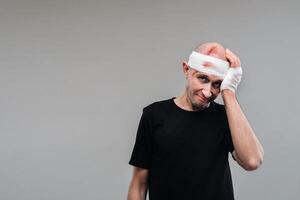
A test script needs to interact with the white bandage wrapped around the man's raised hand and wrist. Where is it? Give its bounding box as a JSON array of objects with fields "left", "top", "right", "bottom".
[{"left": 221, "top": 67, "right": 243, "bottom": 93}]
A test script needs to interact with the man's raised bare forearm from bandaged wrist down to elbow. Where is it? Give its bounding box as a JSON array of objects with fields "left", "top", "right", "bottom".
[{"left": 222, "top": 90, "right": 264, "bottom": 170}]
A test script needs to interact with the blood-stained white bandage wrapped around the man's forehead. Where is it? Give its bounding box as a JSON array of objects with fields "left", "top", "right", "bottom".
[{"left": 188, "top": 51, "right": 229, "bottom": 79}]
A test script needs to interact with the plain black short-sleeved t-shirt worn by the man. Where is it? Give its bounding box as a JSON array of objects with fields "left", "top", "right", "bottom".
[{"left": 129, "top": 97, "right": 234, "bottom": 200}]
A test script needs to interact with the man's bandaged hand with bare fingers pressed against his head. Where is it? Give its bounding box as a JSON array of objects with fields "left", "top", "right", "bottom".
[{"left": 221, "top": 49, "right": 243, "bottom": 93}]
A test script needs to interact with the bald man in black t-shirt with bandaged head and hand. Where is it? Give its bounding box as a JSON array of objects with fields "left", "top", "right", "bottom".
[{"left": 127, "top": 42, "right": 264, "bottom": 200}]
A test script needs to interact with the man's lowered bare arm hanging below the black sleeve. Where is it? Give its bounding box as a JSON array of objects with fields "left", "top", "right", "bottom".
[{"left": 127, "top": 167, "right": 149, "bottom": 200}]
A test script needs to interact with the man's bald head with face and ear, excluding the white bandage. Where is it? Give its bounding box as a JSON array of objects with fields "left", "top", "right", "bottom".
[{"left": 182, "top": 42, "right": 227, "bottom": 109}]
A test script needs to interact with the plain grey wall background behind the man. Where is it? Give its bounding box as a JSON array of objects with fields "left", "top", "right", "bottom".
[{"left": 0, "top": 0, "right": 300, "bottom": 200}]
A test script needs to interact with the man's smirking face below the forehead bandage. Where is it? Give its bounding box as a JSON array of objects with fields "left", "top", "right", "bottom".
[{"left": 186, "top": 66, "right": 222, "bottom": 109}]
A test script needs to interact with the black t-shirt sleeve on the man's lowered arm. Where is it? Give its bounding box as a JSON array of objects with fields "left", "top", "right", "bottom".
[{"left": 128, "top": 108, "right": 152, "bottom": 169}]
